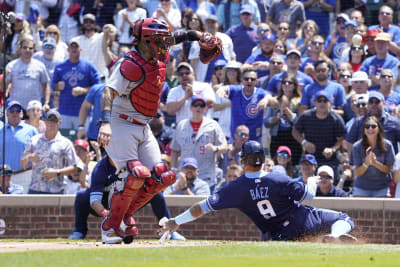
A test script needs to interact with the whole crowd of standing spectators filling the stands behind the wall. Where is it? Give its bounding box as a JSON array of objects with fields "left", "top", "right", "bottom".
[{"left": 0, "top": 0, "right": 400, "bottom": 203}]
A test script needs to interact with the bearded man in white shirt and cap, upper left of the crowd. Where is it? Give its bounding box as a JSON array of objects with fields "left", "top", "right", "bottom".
[{"left": 72, "top": 13, "right": 107, "bottom": 79}]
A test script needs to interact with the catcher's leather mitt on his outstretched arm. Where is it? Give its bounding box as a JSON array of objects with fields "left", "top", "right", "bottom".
[{"left": 199, "top": 32, "right": 222, "bottom": 64}]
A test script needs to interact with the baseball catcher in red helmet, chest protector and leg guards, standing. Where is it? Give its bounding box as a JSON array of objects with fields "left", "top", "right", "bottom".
[{"left": 98, "top": 18, "right": 222, "bottom": 244}]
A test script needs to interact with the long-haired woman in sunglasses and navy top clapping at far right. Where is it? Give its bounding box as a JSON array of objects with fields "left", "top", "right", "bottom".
[{"left": 350, "top": 116, "right": 395, "bottom": 197}]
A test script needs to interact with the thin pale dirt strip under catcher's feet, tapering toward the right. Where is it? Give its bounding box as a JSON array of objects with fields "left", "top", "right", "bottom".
[{"left": 0, "top": 240, "right": 232, "bottom": 253}]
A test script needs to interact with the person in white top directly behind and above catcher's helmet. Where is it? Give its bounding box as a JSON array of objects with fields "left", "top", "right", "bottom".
[{"left": 115, "top": 0, "right": 147, "bottom": 45}]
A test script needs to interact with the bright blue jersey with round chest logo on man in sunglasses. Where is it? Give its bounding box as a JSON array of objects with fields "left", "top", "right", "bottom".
[{"left": 229, "top": 85, "right": 269, "bottom": 141}]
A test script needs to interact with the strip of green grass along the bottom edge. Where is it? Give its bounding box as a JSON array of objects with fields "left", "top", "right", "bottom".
[{"left": 0, "top": 240, "right": 400, "bottom": 267}]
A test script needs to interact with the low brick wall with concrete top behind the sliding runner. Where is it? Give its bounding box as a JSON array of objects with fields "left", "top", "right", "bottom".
[{"left": 0, "top": 195, "right": 400, "bottom": 244}]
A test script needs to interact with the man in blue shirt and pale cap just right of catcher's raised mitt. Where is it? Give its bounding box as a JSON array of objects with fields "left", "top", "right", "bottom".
[{"left": 227, "top": 5, "right": 258, "bottom": 63}]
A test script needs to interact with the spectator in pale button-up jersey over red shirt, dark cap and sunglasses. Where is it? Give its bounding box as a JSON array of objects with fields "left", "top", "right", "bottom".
[{"left": 170, "top": 95, "right": 228, "bottom": 192}]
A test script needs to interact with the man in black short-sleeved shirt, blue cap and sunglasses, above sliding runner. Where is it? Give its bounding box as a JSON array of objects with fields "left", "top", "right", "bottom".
[{"left": 292, "top": 89, "right": 345, "bottom": 175}]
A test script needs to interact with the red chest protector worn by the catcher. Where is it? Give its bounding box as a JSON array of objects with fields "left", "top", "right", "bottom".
[{"left": 120, "top": 51, "right": 166, "bottom": 117}]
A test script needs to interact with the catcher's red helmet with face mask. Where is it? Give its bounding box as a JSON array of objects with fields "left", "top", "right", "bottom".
[{"left": 133, "top": 18, "right": 175, "bottom": 62}]
